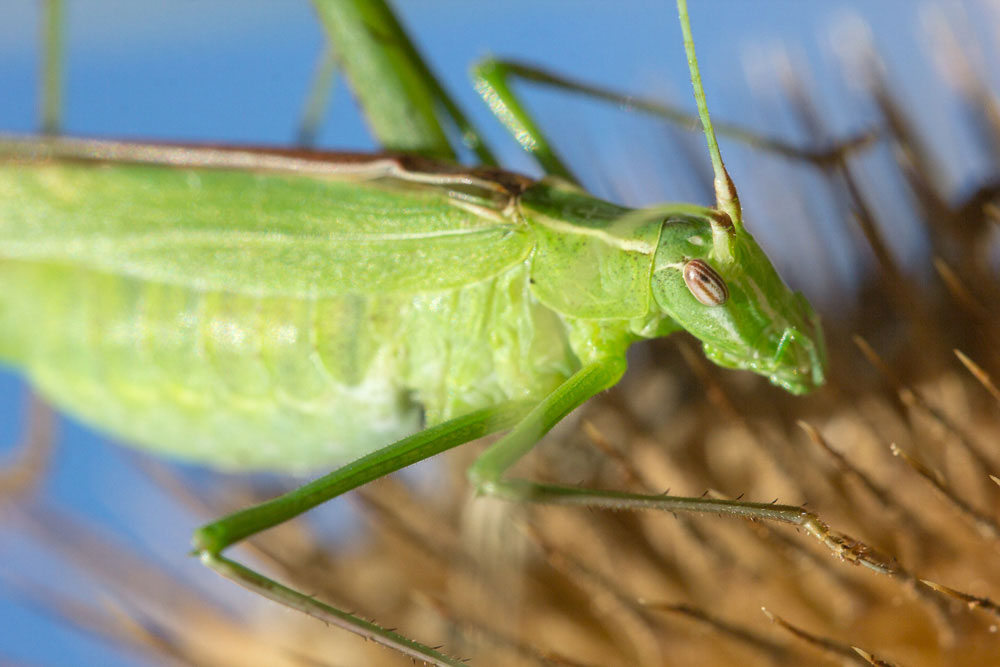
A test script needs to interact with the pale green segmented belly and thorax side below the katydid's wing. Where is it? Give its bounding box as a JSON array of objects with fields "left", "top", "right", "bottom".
[{"left": 0, "top": 261, "right": 576, "bottom": 470}]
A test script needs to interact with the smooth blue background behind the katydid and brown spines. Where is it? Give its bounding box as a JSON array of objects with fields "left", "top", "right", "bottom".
[{"left": 0, "top": 0, "right": 989, "bottom": 665}]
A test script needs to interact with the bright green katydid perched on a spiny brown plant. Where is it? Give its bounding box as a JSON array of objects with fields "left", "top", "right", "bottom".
[{"left": 0, "top": 0, "right": 872, "bottom": 664}]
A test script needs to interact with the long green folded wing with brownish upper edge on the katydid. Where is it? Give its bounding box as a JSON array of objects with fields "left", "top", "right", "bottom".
[{"left": 0, "top": 142, "right": 531, "bottom": 297}]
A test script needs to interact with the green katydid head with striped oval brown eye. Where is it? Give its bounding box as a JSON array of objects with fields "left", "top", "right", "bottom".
[{"left": 652, "top": 211, "right": 826, "bottom": 394}]
